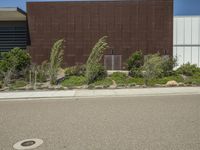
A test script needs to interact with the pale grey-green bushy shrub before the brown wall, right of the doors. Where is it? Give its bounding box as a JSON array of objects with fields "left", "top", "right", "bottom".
[{"left": 142, "top": 54, "right": 163, "bottom": 85}]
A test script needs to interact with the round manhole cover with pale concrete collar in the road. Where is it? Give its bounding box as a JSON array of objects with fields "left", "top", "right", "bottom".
[{"left": 13, "top": 139, "right": 43, "bottom": 150}]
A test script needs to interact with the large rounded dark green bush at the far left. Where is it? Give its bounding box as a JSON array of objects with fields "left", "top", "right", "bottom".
[{"left": 0, "top": 48, "right": 31, "bottom": 72}]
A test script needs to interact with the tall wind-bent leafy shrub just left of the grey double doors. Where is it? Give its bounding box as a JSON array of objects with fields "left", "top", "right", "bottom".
[{"left": 85, "top": 36, "right": 108, "bottom": 84}]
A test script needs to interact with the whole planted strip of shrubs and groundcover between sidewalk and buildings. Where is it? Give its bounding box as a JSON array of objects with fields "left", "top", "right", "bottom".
[{"left": 0, "top": 37, "right": 200, "bottom": 91}]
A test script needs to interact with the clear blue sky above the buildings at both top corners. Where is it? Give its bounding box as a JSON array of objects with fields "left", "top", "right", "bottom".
[{"left": 0, "top": 0, "right": 200, "bottom": 15}]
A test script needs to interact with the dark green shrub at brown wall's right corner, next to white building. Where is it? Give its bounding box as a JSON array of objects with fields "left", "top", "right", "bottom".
[{"left": 161, "top": 56, "right": 177, "bottom": 77}]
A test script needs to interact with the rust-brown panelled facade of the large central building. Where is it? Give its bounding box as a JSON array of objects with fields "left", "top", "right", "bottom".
[{"left": 27, "top": 0, "right": 173, "bottom": 69}]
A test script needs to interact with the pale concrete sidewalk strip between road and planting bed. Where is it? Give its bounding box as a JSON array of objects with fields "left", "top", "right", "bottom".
[{"left": 0, "top": 87, "right": 200, "bottom": 100}]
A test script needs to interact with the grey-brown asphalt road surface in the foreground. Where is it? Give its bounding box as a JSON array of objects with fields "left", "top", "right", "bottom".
[{"left": 0, "top": 95, "right": 200, "bottom": 150}]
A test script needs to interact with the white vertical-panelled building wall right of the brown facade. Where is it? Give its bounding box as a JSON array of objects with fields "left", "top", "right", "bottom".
[{"left": 173, "top": 16, "right": 200, "bottom": 67}]
